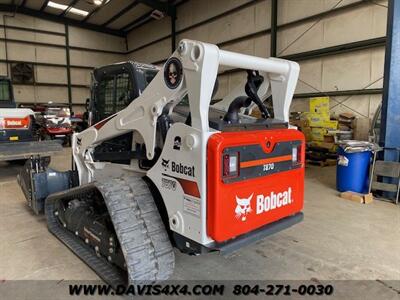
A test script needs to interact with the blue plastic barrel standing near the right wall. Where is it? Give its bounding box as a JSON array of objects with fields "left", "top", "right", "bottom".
[{"left": 336, "top": 146, "right": 372, "bottom": 194}]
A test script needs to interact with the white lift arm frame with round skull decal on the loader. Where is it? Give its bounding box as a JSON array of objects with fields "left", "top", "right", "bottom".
[{"left": 72, "top": 40, "right": 299, "bottom": 184}]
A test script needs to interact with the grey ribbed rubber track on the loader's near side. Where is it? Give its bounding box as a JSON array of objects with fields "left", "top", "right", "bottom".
[{"left": 45, "top": 175, "right": 175, "bottom": 287}]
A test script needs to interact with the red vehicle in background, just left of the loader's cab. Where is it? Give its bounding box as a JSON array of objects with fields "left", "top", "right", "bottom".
[{"left": 37, "top": 104, "right": 73, "bottom": 145}]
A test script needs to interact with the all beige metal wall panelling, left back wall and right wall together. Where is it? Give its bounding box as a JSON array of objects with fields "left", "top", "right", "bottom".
[{"left": 0, "top": 0, "right": 387, "bottom": 117}]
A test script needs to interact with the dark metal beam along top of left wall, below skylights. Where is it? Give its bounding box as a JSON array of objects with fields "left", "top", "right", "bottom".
[{"left": 0, "top": 4, "right": 125, "bottom": 37}]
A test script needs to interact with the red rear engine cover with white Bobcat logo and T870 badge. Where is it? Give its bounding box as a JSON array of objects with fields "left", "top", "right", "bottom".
[{"left": 207, "top": 129, "right": 305, "bottom": 242}]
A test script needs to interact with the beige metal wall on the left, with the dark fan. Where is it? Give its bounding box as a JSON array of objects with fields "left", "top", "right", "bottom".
[{"left": 0, "top": 13, "right": 126, "bottom": 111}]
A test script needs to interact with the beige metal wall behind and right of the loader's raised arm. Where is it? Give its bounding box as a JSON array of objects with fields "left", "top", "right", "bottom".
[{"left": 128, "top": 0, "right": 387, "bottom": 117}]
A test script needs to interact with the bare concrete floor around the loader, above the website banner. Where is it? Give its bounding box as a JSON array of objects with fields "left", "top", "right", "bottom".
[{"left": 0, "top": 149, "right": 400, "bottom": 280}]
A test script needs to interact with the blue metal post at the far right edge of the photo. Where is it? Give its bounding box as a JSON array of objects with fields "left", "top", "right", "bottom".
[{"left": 380, "top": 0, "right": 400, "bottom": 161}]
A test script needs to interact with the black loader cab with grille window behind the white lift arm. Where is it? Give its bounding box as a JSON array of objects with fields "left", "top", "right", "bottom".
[{"left": 87, "top": 61, "right": 159, "bottom": 164}]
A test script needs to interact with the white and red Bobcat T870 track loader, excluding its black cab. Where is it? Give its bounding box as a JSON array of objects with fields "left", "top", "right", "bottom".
[{"left": 17, "top": 40, "right": 305, "bottom": 286}]
